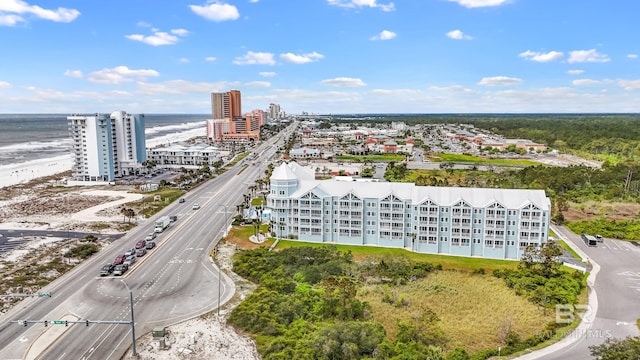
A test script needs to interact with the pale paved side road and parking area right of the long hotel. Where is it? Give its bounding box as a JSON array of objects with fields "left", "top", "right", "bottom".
[{"left": 518, "top": 228, "right": 640, "bottom": 360}]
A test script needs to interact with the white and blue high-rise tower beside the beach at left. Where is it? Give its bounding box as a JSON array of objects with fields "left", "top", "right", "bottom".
[{"left": 67, "top": 111, "right": 146, "bottom": 181}]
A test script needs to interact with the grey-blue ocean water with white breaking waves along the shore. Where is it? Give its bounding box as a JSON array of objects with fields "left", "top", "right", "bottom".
[{"left": 0, "top": 114, "right": 211, "bottom": 166}]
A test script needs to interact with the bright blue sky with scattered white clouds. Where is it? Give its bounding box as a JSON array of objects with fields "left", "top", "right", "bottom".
[{"left": 0, "top": 0, "right": 640, "bottom": 114}]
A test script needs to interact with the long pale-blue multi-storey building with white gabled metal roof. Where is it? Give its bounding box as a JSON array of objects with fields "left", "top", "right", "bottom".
[{"left": 267, "top": 162, "right": 551, "bottom": 259}]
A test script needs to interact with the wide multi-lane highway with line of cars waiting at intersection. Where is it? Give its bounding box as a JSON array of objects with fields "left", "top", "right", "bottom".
[{"left": 0, "top": 130, "right": 290, "bottom": 360}]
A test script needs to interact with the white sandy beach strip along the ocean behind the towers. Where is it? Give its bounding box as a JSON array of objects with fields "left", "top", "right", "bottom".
[{"left": 0, "top": 125, "right": 205, "bottom": 188}]
